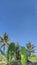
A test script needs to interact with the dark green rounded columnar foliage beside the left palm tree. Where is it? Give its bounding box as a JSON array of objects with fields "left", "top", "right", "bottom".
[{"left": 7, "top": 43, "right": 15, "bottom": 61}]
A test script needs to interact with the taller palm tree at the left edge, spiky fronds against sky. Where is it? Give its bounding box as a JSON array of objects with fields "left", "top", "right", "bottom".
[{"left": 0, "top": 32, "right": 9, "bottom": 50}]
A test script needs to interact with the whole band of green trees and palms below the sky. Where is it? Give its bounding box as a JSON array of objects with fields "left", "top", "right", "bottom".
[{"left": 0, "top": 33, "right": 37, "bottom": 65}]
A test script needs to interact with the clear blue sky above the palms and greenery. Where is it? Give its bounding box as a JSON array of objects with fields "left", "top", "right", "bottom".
[{"left": 0, "top": 0, "right": 37, "bottom": 53}]
